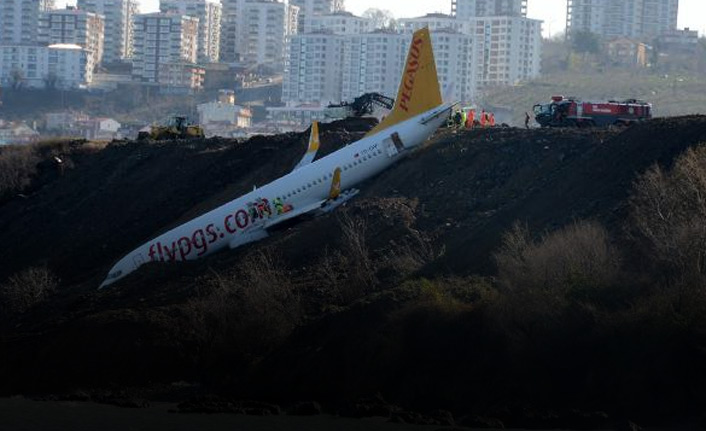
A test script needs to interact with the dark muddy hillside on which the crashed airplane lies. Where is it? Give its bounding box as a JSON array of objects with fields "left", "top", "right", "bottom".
[{"left": 0, "top": 116, "right": 706, "bottom": 424}]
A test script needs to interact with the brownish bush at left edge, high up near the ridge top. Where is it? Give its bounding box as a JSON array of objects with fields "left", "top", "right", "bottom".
[{"left": 0, "top": 145, "right": 40, "bottom": 197}]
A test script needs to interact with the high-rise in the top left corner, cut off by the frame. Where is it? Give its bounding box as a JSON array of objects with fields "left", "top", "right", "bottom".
[{"left": 0, "top": 0, "right": 54, "bottom": 45}]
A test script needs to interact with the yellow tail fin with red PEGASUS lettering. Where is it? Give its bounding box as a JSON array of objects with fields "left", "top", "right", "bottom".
[{"left": 368, "top": 28, "right": 443, "bottom": 135}]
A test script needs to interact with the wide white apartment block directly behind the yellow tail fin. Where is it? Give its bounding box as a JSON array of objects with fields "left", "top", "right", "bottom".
[{"left": 282, "top": 29, "right": 476, "bottom": 107}]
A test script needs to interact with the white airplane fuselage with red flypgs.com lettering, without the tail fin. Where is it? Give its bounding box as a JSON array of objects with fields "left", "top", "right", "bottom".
[{"left": 101, "top": 104, "right": 451, "bottom": 287}]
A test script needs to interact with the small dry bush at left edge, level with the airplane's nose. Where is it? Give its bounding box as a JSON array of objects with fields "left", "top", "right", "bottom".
[{"left": 0, "top": 266, "right": 59, "bottom": 313}]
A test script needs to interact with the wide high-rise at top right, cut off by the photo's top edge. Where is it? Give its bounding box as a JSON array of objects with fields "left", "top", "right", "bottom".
[{"left": 566, "top": 0, "right": 679, "bottom": 42}]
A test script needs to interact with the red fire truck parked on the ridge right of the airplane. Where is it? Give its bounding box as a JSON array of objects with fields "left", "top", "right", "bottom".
[{"left": 534, "top": 96, "right": 652, "bottom": 127}]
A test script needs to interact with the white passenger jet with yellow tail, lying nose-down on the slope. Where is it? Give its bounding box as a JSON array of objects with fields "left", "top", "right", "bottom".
[{"left": 99, "top": 28, "right": 456, "bottom": 289}]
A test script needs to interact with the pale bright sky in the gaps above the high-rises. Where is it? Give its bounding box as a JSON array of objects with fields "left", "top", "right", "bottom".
[{"left": 64, "top": 0, "right": 706, "bottom": 36}]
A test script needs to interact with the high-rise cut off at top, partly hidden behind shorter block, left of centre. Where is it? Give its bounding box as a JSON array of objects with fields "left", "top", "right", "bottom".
[{"left": 159, "top": 0, "right": 222, "bottom": 63}]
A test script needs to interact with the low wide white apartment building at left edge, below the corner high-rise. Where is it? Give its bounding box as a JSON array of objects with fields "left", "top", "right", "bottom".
[{"left": 0, "top": 44, "right": 94, "bottom": 89}]
